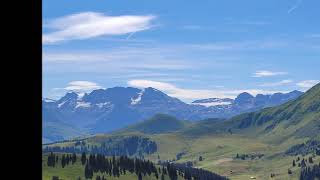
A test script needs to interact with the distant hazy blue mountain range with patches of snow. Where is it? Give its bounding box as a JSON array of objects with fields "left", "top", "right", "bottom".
[{"left": 42, "top": 87, "right": 302, "bottom": 141}]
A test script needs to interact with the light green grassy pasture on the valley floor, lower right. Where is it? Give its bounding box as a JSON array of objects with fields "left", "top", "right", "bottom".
[{"left": 77, "top": 133, "right": 320, "bottom": 179}]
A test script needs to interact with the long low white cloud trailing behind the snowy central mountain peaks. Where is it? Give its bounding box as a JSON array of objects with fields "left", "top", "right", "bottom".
[{"left": 128, "top": 79, "right": 279, "bottom": 101}]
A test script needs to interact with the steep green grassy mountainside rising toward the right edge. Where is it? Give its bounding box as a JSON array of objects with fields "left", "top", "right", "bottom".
[{"left": 185, "top": 84, "right": 320, "bottom": 139}]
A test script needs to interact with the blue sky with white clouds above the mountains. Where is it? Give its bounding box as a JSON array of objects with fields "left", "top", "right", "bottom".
[{"left": 42, "top": 0, "right": 320, "bottom": 102}]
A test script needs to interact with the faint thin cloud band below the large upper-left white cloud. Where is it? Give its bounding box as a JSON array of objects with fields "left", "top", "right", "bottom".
[{"left": 43, "top": 49, "right": 192, "bottom": 75}]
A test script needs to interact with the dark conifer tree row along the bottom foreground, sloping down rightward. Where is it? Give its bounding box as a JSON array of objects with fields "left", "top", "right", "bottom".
[{"left": 48, "top": 152, "right": 227, "bottom": 180}]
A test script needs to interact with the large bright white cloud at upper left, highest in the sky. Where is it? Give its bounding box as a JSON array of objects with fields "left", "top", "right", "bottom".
[{"left": 43, "top": 12, "right": 155, "bottom": 44}]
